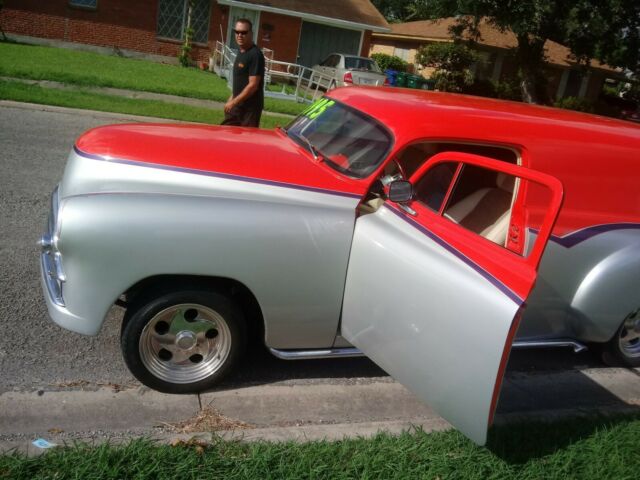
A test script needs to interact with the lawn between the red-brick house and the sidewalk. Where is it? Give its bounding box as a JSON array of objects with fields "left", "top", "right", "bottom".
[{"left": 0, "top": 42, "right": 307, "bottom": 115}]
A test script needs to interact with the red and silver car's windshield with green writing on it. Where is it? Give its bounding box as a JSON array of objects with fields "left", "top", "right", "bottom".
[{"left": 286, "top": 97, "right": 392, "bottom": 178}]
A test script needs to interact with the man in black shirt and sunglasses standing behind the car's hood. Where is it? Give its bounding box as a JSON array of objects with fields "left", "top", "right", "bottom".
[{"left": 222, "top": 18, "right": 264, "bottom": 127}]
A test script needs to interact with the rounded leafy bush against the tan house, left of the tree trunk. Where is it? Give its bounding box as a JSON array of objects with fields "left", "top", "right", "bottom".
[{"left": 416, "top": 43, "right": 478, "bottom": 92}]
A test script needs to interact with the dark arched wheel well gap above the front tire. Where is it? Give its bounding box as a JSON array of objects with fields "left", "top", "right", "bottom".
[{"left": 120, "top": 275, "right": 264, "bottom": 343}]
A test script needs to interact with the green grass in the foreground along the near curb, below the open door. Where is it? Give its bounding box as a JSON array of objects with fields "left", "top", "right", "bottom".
[{"left": 0, "top": 414, "right": 640, "bottom": 480}]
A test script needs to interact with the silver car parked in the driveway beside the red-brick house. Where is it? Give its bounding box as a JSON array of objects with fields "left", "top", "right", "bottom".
[{"left": 311, "top": 53, "right": 389, "bottom": 89}]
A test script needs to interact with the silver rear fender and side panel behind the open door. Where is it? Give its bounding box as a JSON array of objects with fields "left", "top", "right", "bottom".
[{"left": 517, "top": 228, "right": 640, "bottom": 342}]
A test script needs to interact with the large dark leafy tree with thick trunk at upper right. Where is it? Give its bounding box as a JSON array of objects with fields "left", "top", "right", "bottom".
[{"left": 416, "top": 0, "right": 640, "bottom": 103}]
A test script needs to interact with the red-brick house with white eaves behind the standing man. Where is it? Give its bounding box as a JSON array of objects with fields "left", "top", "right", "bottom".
[{"left": 0, "top": 0, "right": 389, "bottom": 66}]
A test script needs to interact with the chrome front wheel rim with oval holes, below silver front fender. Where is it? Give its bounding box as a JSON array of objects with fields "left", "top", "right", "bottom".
[{"left": 139, "top": 303, "right": 231, "bottom": 384}]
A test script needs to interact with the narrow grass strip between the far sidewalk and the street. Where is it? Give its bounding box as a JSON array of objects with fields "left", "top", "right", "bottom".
[{"left": 0, "top": 80, "right": 289, "bottom": 128}]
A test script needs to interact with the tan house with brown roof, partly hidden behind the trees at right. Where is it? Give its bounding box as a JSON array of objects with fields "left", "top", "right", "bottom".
[{"left": 370, "top": 18, "right": 621, "bottom": 100}]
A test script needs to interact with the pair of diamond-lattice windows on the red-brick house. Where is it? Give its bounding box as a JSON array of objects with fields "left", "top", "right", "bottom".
[{"left": 158, "top": 0, "right": 211, "bottom": 43}]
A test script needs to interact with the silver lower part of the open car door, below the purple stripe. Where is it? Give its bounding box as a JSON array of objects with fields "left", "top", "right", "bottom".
[{"left": 342, "top": 207, "right": 520, "bottom": 444}]
